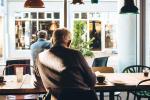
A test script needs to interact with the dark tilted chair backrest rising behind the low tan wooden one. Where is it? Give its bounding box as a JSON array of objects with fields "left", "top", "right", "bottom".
[{"left": 92, "top": 57, "right": 108, "bottom": 67}]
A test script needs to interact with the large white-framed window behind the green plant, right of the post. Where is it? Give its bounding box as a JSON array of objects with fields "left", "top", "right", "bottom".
[{"left": 74, "top": 12, "right": 117, "bottom": 50}]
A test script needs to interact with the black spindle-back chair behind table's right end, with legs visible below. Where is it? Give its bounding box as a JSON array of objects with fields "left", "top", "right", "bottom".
[{"left": 123, "top": 65, "right": 150, "bottom": 100}]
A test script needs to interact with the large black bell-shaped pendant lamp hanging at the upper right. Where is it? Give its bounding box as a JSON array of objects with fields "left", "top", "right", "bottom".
[{"left": 120, "top": 0, "right": 138, "bottom": 14}]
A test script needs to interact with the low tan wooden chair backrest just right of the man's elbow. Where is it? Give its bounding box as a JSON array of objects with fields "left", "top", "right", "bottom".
[{"left": 92, "top": 66, "right": 114, "bottom": 73}]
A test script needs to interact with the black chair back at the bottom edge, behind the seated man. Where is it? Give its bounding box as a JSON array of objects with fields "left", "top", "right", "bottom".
[{"left": 58, "top": 88, "right": 98, "bottom": 100}]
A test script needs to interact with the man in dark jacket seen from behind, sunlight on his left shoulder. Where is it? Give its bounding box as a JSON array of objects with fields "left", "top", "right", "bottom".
[{"left": 36, "top": 28, "right": 96, "bottom": 100}]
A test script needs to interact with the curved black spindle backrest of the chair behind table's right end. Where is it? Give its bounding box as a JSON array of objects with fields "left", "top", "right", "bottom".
[{"left": 123, "top": 65, "right": 150, "bottom": 73}]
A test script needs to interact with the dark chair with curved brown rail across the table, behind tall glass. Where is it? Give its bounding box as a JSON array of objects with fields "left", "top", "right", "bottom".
[{"left": 3, "top": 59, "right": 38, "bottom": 100}]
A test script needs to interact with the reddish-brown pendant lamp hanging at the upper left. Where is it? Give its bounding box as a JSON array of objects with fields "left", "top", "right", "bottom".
[{"left": 24, "top": 0, "right": 45, "bottom": 8}]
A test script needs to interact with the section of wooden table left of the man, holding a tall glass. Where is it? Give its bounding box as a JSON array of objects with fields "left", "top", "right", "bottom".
[{"left": 0, "top": 74, "right": 46, "bottom": 95}]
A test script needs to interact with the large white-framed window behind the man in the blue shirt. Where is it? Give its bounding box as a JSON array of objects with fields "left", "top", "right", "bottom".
[{"left": 15, "top": 12, "right": 60, "bottom": 49}]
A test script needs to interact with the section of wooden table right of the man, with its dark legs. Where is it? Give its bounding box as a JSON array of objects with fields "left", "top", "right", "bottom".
[{"left": 95, "top": 73, "right": 150, "bottom": 100}]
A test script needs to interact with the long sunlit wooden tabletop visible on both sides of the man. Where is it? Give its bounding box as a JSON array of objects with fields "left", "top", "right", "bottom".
[{"left": 0, "top": 73, "right": 150, "bottom": 95}]
